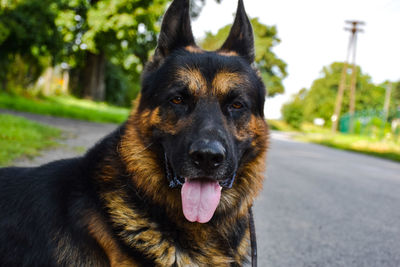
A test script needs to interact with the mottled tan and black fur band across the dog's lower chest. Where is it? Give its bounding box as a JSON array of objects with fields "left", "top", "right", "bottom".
[{"left": 104, "top": 189, "right": 238, "bottom": 267}]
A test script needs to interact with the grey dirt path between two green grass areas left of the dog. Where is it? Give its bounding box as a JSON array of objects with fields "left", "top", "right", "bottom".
[{"left": 0, "top": 109, "right": 118, "bottom": 166}]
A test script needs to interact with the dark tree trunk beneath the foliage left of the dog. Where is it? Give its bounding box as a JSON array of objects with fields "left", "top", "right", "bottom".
[{"left": 83, "top": 52, "right": 106, "bottom": 101}]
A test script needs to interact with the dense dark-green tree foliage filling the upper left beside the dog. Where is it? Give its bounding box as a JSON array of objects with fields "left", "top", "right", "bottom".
[{"left": 0, "top": 0, "right": 219, "bottom": 105}]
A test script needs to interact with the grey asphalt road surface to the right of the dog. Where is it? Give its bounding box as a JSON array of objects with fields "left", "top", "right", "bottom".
[{"left": 254, "top": 133, "right": 400, "bottom": 267}]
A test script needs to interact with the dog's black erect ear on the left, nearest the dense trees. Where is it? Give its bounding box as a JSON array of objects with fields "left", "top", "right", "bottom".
[{"left": 156, "top": 0, "right": 195, "bottom": 57}]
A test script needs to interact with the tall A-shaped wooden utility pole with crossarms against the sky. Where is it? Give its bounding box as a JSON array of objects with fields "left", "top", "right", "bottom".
[{"left": 332, "top": 21, "right": 365, "bottom": 133}]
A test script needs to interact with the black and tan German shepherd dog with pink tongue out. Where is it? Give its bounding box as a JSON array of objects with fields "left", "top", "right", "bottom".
[{"left": 0, "top": 0, "right": 268, "bottom": 267}]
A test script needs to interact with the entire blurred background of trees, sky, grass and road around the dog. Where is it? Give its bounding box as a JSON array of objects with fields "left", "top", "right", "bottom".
[{"left": 0, "top": 0, "right": 400, "bottom": 267}]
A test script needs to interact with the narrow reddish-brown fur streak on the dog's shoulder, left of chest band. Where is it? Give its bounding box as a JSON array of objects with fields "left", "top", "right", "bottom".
[{"left": 88, "top": 215, "right": 139, "bottom": 267}]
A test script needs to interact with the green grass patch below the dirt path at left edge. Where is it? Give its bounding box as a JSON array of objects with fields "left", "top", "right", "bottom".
[{"left": 0, "top": 114, "right": 61, "bottom": 166}]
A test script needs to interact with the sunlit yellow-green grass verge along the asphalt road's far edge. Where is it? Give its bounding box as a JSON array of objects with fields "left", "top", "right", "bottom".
[{"left": 269, "top": 121, "right": 400, "bottom": 162}]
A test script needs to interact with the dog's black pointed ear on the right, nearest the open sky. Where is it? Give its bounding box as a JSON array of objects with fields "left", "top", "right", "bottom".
[{"left": 219, "top": 0, "right": 254, "bottom": 64}]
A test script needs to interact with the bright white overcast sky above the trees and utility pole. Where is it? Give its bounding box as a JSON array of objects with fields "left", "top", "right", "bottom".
[{"left": 192, "top": 0, "right": 400, "bottom": 118}]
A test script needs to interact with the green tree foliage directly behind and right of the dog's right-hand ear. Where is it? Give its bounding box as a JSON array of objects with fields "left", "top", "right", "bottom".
[{"left": 201, "top": 18, "right": 287, "bottom": 96}]
